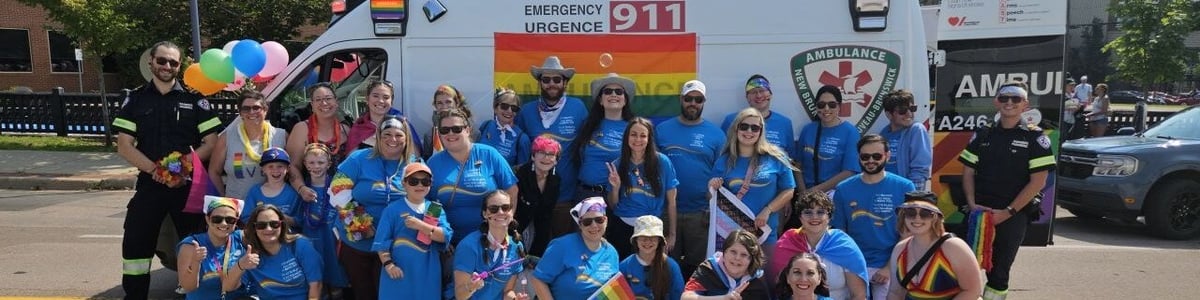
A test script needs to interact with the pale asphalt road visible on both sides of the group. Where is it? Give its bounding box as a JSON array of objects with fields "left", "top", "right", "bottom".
[{"left": 0, "top": 190, "right": 1200, "bottom": 300}]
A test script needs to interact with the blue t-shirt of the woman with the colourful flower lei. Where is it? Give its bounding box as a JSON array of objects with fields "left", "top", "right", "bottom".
[{"left": 331, "top": 149, "right": 420, "bottom": 252}]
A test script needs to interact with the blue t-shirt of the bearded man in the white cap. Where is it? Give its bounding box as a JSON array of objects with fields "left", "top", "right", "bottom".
[{"left": 654, "top": 118, "right": 725, "bottom": 214}]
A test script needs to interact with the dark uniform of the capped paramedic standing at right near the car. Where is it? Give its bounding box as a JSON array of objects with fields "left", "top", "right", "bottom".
[{"left": 959, "top": 120, "right": 1055, "bottom": 298}]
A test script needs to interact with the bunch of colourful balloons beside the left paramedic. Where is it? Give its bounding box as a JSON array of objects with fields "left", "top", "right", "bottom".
[{"left": 184, "top": 40, "right": 289, "bottom": 96}]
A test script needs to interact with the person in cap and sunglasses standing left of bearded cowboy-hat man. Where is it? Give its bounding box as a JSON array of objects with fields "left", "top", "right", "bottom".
[{"left": 479, "top": 88, "right": 529, "bottom": 168}]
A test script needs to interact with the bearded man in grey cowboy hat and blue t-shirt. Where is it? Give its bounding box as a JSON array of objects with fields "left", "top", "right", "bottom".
[{"left": 516, "top": 56, "right": 588, "bottom": 238}]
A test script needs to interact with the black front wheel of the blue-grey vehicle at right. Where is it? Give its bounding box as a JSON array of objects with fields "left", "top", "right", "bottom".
[{"left": 1146, "top": 179, "right": 1200, "bottom": 240}]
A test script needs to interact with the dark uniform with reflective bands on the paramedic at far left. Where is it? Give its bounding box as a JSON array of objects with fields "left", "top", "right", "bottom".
[{"left": 113, "top": 80, "right": 221, "bottom": 299}]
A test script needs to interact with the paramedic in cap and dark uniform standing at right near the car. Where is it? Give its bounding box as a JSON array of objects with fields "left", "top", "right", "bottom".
[{"left": 959, "top": 83, "right": 1055, "bottom": 299}]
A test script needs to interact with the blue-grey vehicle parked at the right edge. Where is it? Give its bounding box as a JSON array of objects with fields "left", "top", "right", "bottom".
[{"left": 1055, "top": 107, "right": 1200, "bottom": 240}]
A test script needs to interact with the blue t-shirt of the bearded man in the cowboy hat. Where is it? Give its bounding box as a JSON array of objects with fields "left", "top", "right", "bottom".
[{"left": 516, "top": 96, "right": 588, "bottom": 203}]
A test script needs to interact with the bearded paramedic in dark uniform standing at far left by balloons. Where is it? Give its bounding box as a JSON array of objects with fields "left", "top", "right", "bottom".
[{"left": 113, "top": 42, "right": 221, "bottom": 299}]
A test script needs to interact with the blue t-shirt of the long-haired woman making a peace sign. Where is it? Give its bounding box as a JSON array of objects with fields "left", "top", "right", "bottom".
[{"left": 612, "top": 154, "right": 679, "bottom": 218}]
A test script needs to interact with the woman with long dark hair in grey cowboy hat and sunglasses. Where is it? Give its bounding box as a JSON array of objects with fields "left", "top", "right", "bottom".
[{"left": 569, "top": 73, "right": 637, "bottom": 199}]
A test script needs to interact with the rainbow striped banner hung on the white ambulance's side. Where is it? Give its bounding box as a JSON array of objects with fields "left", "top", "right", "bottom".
[{"left": 493, "top": 32, "right": 696, "bottom": 118}]
